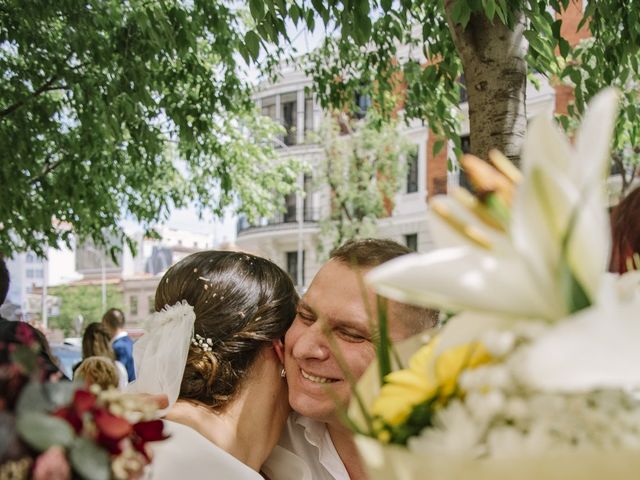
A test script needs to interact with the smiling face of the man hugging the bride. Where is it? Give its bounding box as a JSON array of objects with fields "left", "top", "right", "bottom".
[{"left": 284, "top": 260, "right": 406, "bottom": 422}]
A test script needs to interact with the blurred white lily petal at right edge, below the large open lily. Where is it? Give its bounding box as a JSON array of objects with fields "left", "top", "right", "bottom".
[{"left": 513, "top": 272, "right": 640, "bottom": 392}]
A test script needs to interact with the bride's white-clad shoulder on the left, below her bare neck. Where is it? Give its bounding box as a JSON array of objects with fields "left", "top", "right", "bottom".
[{"left": 149, "top": 420, "right": 262, "bottom": 480}]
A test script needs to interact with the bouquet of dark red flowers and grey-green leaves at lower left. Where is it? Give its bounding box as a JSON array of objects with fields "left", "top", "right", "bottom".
[{"left": 0, "top": 322, "right": 166, "bottom": 480}]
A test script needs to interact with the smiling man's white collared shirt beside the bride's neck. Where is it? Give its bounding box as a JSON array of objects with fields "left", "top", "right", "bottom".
[{"left": 278, "top": 413, "right": 349, "bottom": 480}]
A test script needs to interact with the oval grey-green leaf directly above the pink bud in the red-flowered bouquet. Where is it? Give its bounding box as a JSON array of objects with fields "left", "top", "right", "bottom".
[{"left": 16, "top": 412, "right": 75, "bottom": 452}]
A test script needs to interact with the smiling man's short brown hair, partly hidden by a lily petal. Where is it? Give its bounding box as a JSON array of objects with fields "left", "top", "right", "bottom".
[{"left": 329, "top": 238, "right": 438, "bottom": 334}]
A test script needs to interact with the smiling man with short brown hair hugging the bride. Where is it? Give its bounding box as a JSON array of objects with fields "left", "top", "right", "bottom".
[{"left": 280, "top": 239, "right": 437, "bottom": 480}]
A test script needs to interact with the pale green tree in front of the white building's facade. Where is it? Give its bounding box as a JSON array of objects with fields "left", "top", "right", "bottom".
[{"left": 316, "top": 109, "right": 410, "bottom": 250}]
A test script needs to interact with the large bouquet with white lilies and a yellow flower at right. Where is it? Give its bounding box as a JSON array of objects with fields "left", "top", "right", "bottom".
[{"left": 349, "top": 90, "right": 640, "bottom": 480}]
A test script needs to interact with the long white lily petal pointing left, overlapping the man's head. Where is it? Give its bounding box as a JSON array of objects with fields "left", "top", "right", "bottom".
[{"left": 366, "top": 247, "right": 562, "bottom": 319}]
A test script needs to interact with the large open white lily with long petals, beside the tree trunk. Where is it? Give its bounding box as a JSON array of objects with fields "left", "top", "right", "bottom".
[{"left": 367, "top": 89, "right": 618, "bottom": 322}]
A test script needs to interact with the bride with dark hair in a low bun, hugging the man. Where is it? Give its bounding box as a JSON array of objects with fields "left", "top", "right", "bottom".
[{"left": 129, "top": 251, "right": 310, "bottom": 480}]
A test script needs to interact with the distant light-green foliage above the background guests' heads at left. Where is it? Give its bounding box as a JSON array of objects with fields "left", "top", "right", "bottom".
[{"left": 49, "top": 285, "right": 124, "bottom": 336}]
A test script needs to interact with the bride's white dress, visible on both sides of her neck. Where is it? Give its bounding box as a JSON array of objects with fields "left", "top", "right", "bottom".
[{"left": 145, "top": 420, "right": 311, "bottom": 480}]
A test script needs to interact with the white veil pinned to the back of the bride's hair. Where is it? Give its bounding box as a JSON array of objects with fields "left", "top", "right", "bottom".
[{"left": 127, "top": 301, "right": 196, "bottom": 416}]
